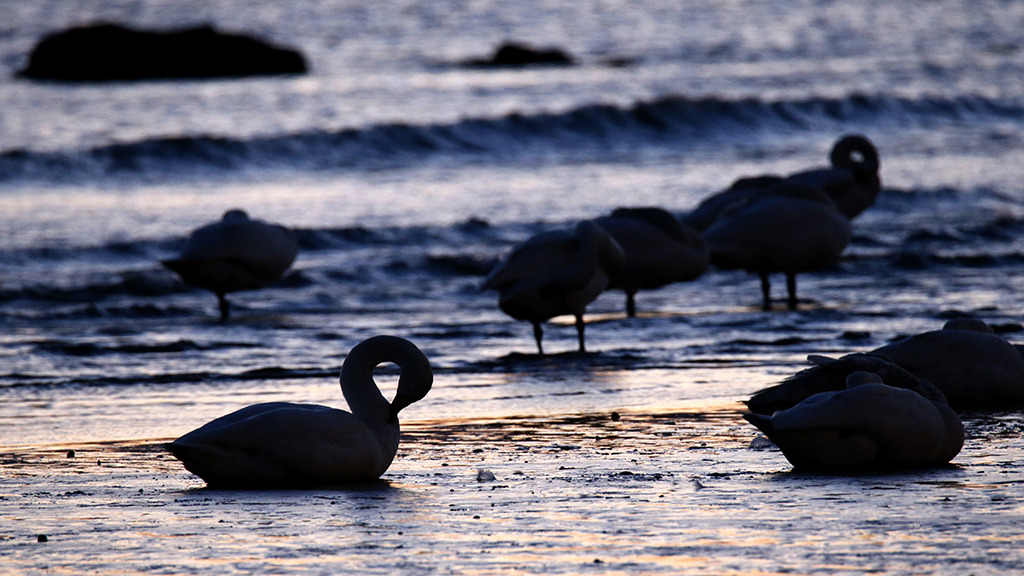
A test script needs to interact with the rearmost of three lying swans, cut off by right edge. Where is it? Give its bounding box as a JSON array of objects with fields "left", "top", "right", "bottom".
[{"left": 874, "top": 318, "right": 1024, "bottom": 410}]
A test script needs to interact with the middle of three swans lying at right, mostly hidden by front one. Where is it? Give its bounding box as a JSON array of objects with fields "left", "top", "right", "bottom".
[{"left": 744, "top": 353, "right": 947, "bottom": 415}]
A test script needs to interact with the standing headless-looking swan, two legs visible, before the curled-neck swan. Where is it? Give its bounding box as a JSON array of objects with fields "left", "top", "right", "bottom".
[{"left": 701, "top": 182, "right": 852, "bottom": 311}]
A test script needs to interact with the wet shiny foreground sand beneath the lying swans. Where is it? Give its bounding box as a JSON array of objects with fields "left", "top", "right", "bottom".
[{"left": 0, "top": 404, "right": 1024, "bottom": 574}]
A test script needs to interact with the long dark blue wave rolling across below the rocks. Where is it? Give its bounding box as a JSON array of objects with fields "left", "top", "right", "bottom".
[{"left": 0, "top": 94, "right": 1024, "bottom": 182}]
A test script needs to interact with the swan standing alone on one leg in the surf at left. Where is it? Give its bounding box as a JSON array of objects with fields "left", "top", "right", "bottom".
[{"left": 161, "top": 209, "right": 299, "bottom": 321}]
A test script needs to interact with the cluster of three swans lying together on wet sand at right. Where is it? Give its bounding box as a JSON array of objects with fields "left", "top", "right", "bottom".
[{"left": 743, "top": 319, "right": 1024, "bottom": 472}]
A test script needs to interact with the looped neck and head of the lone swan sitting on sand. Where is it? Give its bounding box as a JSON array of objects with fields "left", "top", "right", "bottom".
[{"left": 341, "top": 336, "right": 433, "bottom": 424}]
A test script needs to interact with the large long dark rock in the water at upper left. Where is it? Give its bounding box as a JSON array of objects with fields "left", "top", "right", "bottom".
[{"left": 17, "top": 24, "right": 307, "bottom": 82}]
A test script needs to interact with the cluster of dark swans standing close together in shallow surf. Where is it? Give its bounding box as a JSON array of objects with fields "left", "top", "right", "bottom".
[{"left": 482, "top": 134, "right": 882, "bottom": 354}]
